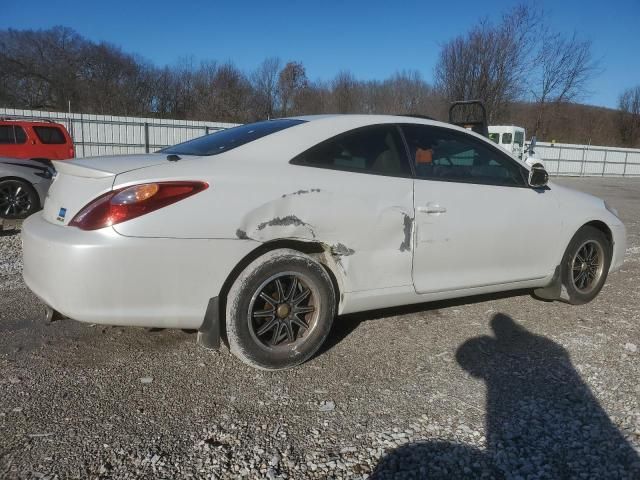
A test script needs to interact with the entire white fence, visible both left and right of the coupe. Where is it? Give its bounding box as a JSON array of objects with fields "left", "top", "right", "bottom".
[{"left": 0, "top": 108, "right": 640, "bottom": 177}]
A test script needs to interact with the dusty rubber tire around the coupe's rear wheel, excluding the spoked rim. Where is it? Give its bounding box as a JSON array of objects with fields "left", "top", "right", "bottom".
[{"left": 226, "top": 249, "right": 336, "bottom": 370}]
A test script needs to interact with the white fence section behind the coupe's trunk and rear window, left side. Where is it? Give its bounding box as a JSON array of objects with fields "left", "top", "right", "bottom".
[{"left": 0, "top": 108, "right": 235, "bottom": 157}]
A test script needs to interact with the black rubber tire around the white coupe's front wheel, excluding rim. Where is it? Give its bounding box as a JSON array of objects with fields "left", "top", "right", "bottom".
[{"left": 562, "top": 225, "right": 612, "bottom": 305}]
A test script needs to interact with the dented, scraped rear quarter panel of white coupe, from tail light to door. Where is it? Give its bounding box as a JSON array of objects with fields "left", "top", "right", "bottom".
[{"left": 114, "top": 128, "right": 414, "bottom": 292}]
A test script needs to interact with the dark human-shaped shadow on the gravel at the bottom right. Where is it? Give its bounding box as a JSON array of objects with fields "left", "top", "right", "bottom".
[{"left": 372, "top": 314, "right": 640, "bottom": 480}]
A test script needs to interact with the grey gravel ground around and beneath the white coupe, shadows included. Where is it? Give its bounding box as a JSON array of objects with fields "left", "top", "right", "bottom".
[{"left": 0, "top": 178, "right": 640, "bottom": 479}]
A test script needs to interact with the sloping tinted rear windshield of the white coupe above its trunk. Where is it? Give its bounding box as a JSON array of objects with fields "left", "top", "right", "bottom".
[{"left": 160, "top": 119, "right": 304, "bottom": 155}]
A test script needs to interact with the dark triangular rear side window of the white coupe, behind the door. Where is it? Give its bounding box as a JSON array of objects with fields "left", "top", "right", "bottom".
[{"left": 291, "top": 125, "right": 411, "bottom": 177}]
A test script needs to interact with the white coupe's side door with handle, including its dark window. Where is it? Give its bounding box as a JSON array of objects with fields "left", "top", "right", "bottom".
[{"left": 403, "top": 125, "right": 561, "bottom": 293}]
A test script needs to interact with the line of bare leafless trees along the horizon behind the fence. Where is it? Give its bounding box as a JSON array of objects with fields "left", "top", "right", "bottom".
[{"left": 0, "top": 4, "right": 640, "bottom": 146}]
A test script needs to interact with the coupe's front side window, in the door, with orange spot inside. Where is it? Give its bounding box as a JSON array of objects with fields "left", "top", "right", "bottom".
[{"left": 402, "top": 125, "right": 526, "bottom": 186}]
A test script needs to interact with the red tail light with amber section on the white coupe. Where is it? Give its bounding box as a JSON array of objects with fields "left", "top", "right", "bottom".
[{"left": 69, "top": 182, "right": 209, "bottom": 230}]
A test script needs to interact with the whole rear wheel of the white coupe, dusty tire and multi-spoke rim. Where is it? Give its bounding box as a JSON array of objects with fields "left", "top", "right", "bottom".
[{"left": 226, "top": 249, "right": 336, "bottom": 370}]
